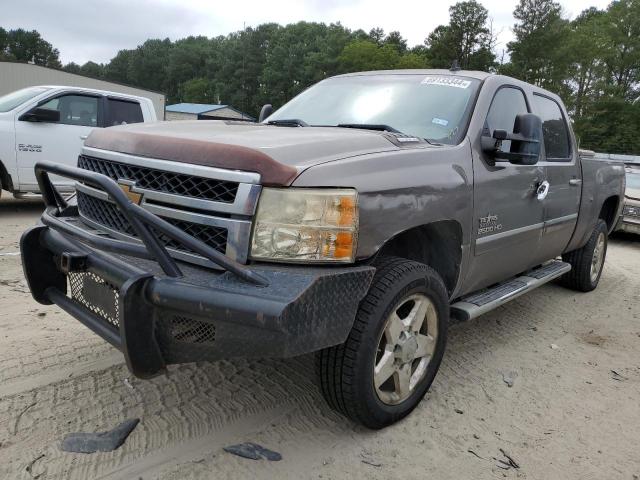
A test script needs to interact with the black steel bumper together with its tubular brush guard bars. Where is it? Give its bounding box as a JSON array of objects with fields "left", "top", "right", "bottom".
[{"left": 20, "top": 162, "right": 375, "bottom": 378}]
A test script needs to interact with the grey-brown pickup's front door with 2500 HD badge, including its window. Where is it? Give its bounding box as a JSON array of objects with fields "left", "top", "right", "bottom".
[{"left": 465, "top": 86, "right": 545, "bottom": 291}]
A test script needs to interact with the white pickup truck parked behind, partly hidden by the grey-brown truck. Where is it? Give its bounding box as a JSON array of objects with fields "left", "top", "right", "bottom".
[{"left": 0, "top": 86, "right": 157, "bottom": 198}]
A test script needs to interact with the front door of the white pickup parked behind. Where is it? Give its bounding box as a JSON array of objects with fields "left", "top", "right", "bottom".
[{"left": 16, "top": 93, "right": 101, "bottom": 190}]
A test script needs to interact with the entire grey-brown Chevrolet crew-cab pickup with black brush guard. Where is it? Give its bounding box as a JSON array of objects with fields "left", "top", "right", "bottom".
[{"left": 21, "top": 70, "right": 624, "bottom": 429}]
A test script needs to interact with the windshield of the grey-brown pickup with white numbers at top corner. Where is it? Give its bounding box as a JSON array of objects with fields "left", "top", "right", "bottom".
[{"left": 268, "top": 74, "right": 480, "bottom": 144}]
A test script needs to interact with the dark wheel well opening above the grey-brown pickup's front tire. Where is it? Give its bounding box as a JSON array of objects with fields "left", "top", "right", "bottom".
[{"left": 378, "top": 220, "right": 462, "bottom": 295}]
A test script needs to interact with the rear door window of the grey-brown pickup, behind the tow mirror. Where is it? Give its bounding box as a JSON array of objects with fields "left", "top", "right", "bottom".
[{"left": 533, "top": 94, "right": 571, "bottom": 161}]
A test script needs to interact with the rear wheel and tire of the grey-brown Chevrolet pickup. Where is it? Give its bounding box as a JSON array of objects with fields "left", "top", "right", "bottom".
[{"left": 560, "top": 219, "right": 608, "bottom": 292}]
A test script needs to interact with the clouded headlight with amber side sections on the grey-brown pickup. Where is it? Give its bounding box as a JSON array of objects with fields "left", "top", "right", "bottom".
[{"left": 251, "top": 188, "right": 358, "bottom": 263}]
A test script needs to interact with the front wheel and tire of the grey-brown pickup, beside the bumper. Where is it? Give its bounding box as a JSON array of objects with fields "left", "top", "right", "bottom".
[{"left": 316, "top": 257, "right": 449, "bottom": 429}]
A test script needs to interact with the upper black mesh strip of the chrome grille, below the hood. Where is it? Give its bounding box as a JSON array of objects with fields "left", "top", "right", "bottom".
[{"left": 78, "top": 155, "right": 238, "bottom": 203}]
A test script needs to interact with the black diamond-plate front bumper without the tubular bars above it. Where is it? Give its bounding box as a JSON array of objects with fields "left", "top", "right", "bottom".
[{"left": 21, "top": 226, "right": 374, "bottom": 378}]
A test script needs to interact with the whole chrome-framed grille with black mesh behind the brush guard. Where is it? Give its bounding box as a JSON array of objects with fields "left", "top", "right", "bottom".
[{"left": 76, "top": 147, "right": 262, "bottom": 268}]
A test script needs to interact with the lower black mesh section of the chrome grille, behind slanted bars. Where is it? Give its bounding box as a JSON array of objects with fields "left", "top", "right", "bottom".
[{"left": 78, "top": 191, "right": 227, "bottom": 254}]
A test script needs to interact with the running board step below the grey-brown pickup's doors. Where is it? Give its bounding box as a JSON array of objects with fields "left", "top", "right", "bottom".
[{"left": 451, "top": 260, "right": 571, "bottom": 321}]
